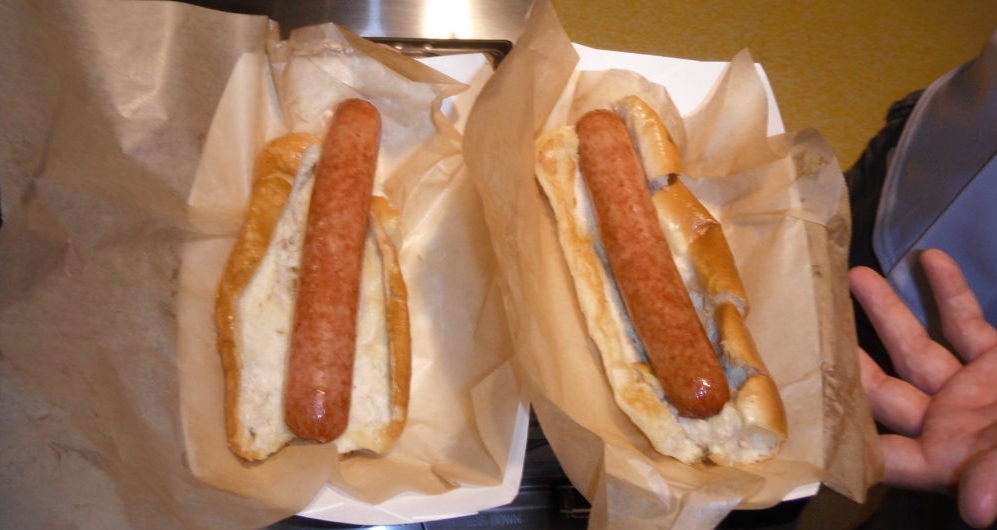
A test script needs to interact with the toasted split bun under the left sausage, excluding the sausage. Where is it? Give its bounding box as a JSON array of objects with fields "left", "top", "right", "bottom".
[{"left": 216, "top": 134, "right": 411, "bottom": 460}]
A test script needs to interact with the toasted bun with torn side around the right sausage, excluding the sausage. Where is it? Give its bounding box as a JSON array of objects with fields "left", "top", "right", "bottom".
[{"left": 535, "top": 98, "right": 786, "bottom": 465}]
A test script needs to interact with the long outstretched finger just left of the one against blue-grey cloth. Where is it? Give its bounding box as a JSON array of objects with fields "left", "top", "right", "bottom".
[{"left": 849, "top": 267, "right": 962, "bottom": 394}]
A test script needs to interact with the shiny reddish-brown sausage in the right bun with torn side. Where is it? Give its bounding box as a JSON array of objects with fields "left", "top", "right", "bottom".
[{"left": 575, "top": 110, "right": 730, "bottom": 418}]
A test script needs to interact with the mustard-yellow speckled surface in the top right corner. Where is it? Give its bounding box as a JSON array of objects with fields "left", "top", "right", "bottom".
[{"left": 554, "top": 0, "right": 997, "bottom": 169}]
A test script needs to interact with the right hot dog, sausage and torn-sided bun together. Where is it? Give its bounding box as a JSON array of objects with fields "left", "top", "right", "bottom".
[{"left": 535, "top": 97, "right": 786, "bottom": 465}]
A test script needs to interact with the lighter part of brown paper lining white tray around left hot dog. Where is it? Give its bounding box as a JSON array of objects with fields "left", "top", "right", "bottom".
[{"left": 179, "top": 18, "right": 520, "bottom": 511}]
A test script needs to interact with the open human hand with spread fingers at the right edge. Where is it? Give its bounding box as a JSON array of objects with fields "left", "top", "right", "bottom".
[{"left": 850, "top": 249, "right": 997, "bottom": 527}]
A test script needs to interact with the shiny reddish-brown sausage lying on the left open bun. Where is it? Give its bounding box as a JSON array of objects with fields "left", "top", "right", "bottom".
[{"left": 284, "top": 99, "right": 381, "bottom": 443}]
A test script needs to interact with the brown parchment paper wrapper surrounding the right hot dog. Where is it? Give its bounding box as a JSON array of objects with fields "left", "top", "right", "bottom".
[{"left": 464, "top": 2, "right": 881, "bottom": 528}]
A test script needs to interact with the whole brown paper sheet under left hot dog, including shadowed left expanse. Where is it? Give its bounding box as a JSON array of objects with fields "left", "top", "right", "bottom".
[{"left": 0, "top": 0, "right": 519, "bottom": 529}]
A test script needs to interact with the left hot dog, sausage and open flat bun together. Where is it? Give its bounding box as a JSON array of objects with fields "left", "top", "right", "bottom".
[{"left": 216, "top": 100, "right": 411, "bottom": 460}]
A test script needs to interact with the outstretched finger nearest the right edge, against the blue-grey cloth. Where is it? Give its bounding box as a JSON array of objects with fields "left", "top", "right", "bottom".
[{"left": 921, "top": 249, "right": 997, "bottom": 362}]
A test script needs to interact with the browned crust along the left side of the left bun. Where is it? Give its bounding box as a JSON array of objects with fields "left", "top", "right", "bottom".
[{"left": 215, "top": 133, "right": 319, "bottom": 460}]
